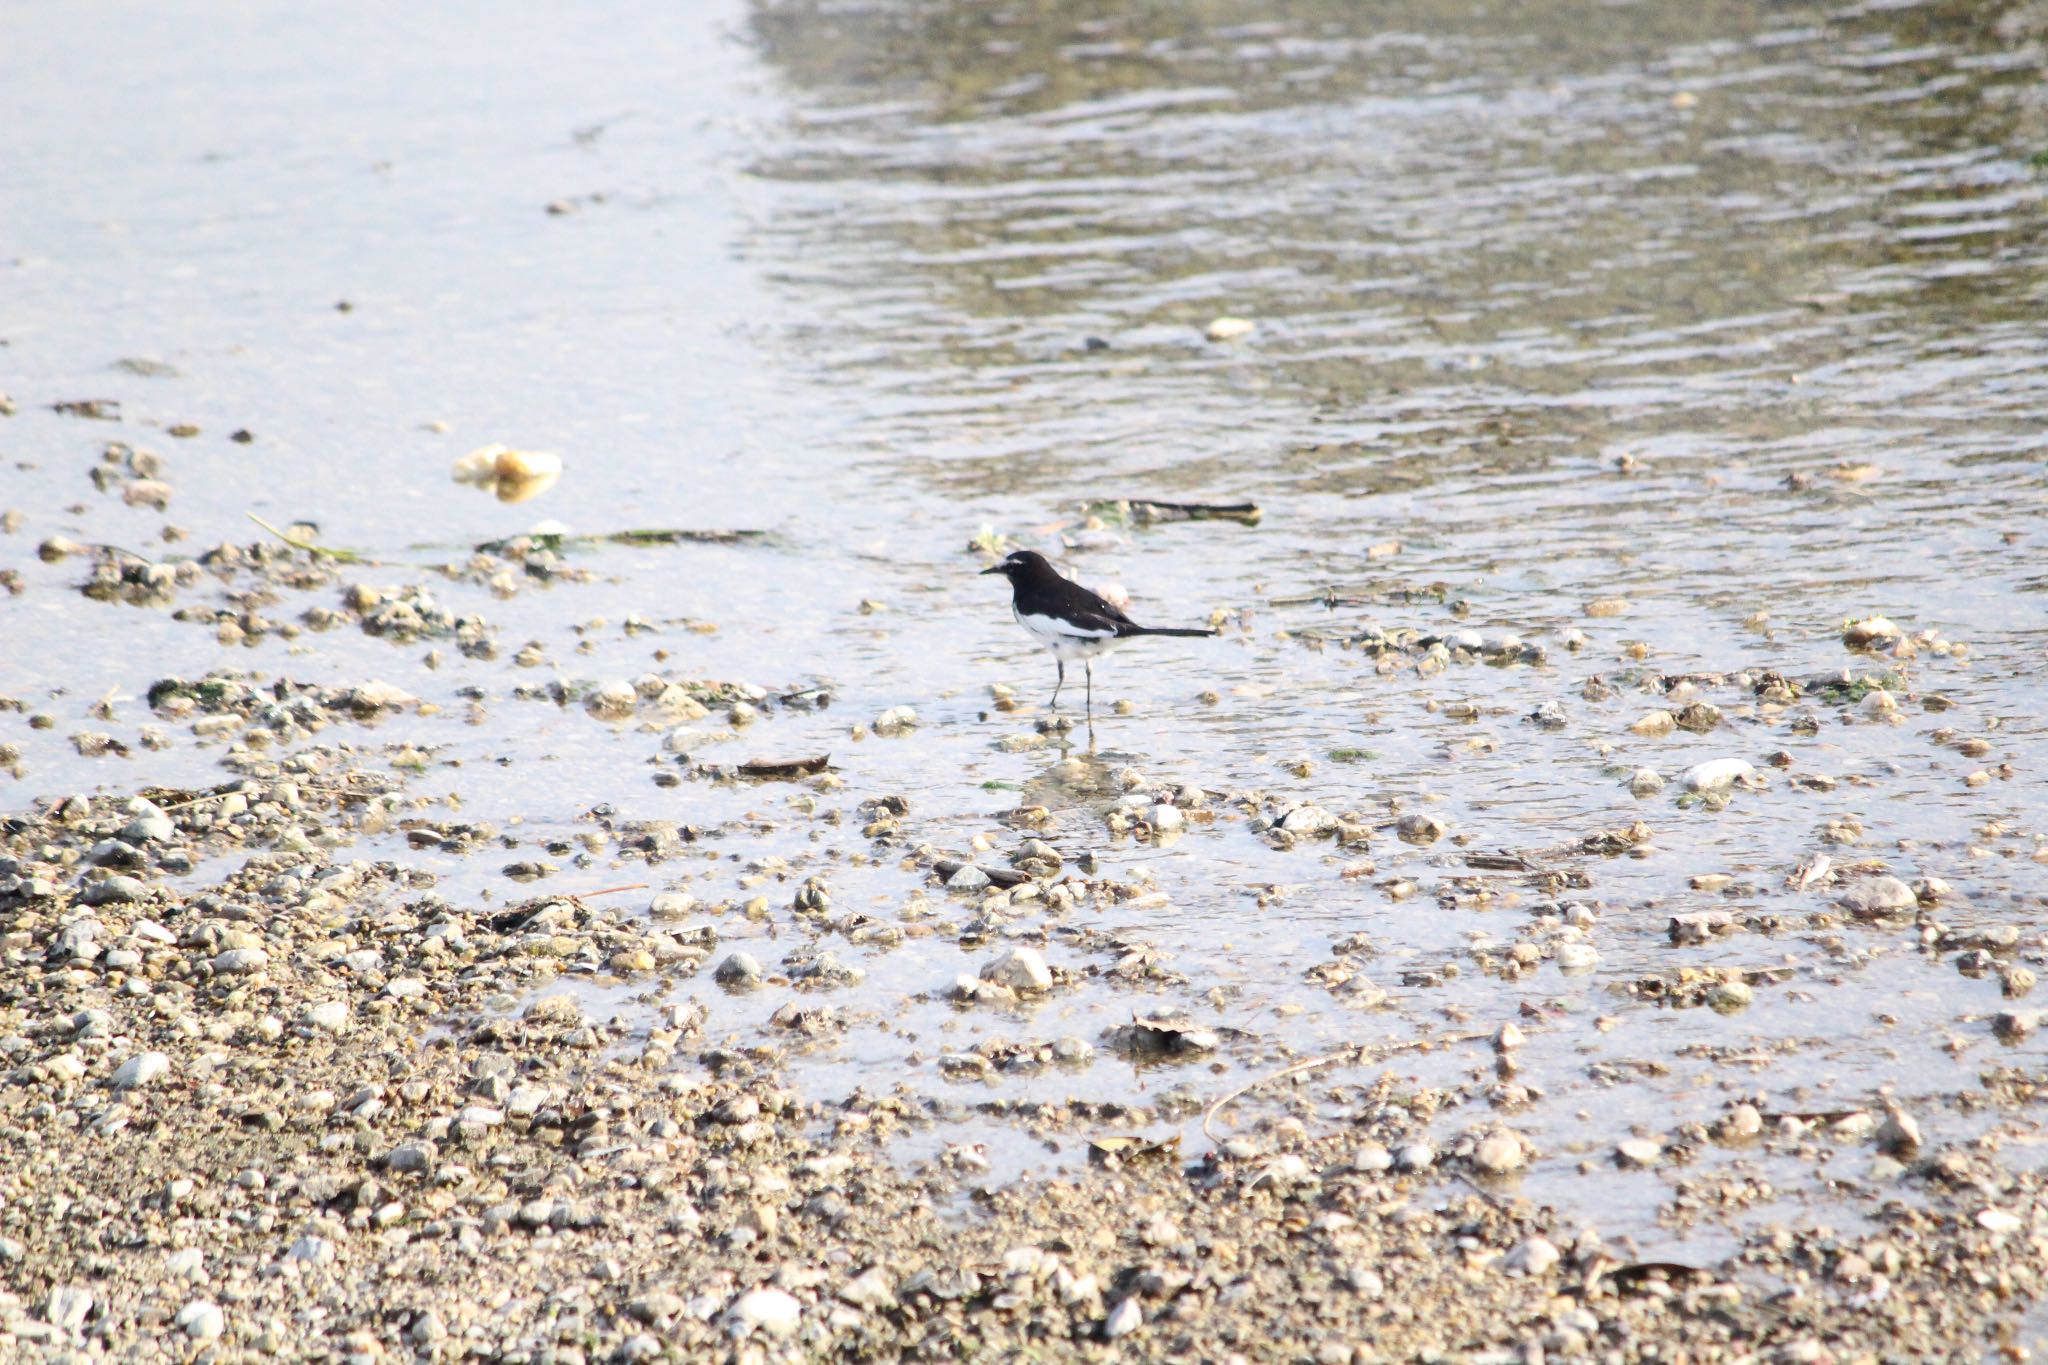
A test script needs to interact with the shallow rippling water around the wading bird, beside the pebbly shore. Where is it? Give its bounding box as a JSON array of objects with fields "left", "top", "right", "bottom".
[{"left": 0, "top": 0, "right": 2048, "bottom": 1285}]
